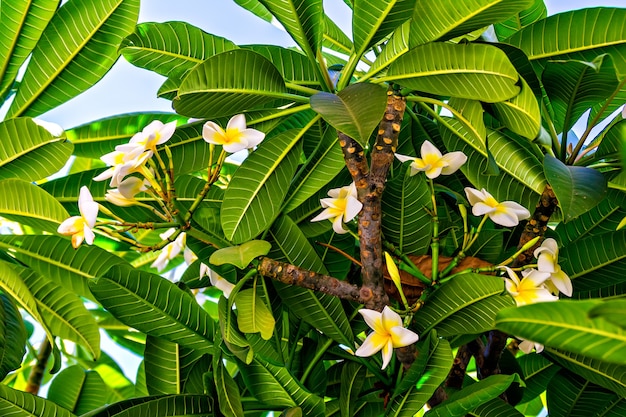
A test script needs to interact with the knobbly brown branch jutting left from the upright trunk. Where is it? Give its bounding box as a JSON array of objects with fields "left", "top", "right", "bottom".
[{"left": 257, "top": 258, "right": 371, "bottom": 304}]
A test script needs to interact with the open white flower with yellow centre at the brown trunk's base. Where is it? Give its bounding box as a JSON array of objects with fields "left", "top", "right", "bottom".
[{"left": 354, "top": 306, "right": 419, "bottom": 369}]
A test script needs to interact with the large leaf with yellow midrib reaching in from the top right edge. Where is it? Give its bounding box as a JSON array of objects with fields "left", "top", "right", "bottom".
[{"left": 506, "top": 7, "right": 626, "bottom": 78}]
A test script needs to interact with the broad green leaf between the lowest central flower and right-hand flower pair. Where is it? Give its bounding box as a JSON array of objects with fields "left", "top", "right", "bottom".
[{"left": 414, "top": 273, "right": 513, "bottom": 337}]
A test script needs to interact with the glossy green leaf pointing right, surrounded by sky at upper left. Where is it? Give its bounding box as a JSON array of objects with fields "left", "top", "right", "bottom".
[{"left": 120, "top": 22, "right": 237, "bottom": 77}]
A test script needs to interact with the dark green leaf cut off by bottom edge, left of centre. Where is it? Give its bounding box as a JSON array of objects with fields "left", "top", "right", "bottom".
[{"left": 81, "top": 394, "right": 214, "bottom": 417}]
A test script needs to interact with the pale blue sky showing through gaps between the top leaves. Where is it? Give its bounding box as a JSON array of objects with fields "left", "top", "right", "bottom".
[{"left": 41, "top": 0, "right": 624, "bottom": 129}]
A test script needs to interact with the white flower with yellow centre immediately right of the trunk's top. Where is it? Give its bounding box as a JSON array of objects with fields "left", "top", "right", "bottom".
[{"left": 396, "top": 140, "right": 467, "bottom": 180}]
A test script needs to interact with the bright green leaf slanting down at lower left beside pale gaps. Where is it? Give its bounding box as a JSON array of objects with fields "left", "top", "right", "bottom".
[{"left": 15, "top": 267, "right": 100, "bottom": 360}]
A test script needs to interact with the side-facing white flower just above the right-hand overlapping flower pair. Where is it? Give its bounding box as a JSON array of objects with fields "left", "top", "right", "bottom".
[{"left": 465, "top": 187, "right": 530, "bottom": 227}]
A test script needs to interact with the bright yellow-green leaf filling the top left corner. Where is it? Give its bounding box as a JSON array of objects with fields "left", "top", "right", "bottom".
[{"left": 0, "top": 0, "right": 60, "bottom": 97}]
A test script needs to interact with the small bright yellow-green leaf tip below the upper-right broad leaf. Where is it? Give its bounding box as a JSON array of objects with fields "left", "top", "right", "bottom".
[{"left": 492, "top": 77, "right": 541, "bottom": 140}]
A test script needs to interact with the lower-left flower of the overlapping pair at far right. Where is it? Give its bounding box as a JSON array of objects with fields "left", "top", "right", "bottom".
[{"left": 502, "top": 266, "right": 559, "bottom": 306}]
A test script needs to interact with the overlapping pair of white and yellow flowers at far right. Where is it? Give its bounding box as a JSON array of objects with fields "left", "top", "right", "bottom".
[{"left": 502, "top": 238, "right": 573, "bottom": 306}]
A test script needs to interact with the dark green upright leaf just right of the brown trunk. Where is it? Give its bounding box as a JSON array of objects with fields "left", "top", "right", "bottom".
[{"left": 382, "top": 164, "right": 432, "bottom": 255}]
